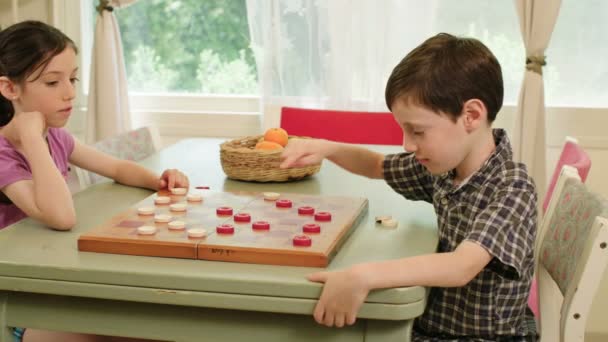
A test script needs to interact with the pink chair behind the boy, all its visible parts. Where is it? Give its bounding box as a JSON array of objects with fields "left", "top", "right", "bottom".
[{"left": 528, "top": 137, "right": 591, "bottom": 317}]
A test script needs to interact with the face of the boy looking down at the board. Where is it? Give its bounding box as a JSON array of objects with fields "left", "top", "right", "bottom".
[{"left": 392, "top": 99, "right": 471, "bottom": 175}]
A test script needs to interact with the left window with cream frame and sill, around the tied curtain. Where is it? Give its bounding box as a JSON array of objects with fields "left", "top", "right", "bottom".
[{"left": 70, "top": 0, "right": 260, "bottom": 143}]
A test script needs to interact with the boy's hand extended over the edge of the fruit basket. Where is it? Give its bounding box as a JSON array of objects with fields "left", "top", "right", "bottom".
[{"left": 280, "top": 139, "right": 332, "bottom": 169}]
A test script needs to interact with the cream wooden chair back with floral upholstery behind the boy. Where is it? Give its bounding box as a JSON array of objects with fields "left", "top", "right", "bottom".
[{"left": 536, "top": 166, "right": 608, "bottom": 342}]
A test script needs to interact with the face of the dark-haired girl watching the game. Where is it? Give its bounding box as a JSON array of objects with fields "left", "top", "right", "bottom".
[{"left": 13, "top": 47, "right": 78, "bottom": 127}]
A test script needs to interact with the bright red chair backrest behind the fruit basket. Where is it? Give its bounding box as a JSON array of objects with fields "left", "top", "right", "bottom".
[{"left": 281, "top": 107, "right": 403, "bottom": 145}]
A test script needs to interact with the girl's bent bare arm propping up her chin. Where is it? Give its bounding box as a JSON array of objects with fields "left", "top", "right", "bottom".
[{"left": 2, "top": 132, "right": 76, "bottom": 230}]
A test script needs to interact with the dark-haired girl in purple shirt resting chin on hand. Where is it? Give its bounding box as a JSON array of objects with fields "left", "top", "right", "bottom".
[{"left": 0, "top": 21, "right": 189, "bottom": 342}]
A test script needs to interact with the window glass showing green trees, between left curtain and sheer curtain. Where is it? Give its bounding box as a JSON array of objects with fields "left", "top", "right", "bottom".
[{"left": 115, "top": 0, "right": 257, "bottom": 95}]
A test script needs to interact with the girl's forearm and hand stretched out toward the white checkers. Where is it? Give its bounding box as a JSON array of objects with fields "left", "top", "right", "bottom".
[{"left": 70, "top": 141, "right": 189, "bottom": 190}]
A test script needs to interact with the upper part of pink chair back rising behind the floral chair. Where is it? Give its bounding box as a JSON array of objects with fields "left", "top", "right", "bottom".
[{"left": 543, "top": 137, "right": 591, "bottom": 212}]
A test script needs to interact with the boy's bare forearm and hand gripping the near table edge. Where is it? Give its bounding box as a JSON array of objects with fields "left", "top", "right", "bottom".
[{"left": 308, "top": 241, "right": 492, "bottom": 327}]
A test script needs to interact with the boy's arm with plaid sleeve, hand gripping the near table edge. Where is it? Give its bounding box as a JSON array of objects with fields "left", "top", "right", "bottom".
[{"left": 309, "top": 174, "right": 536, "bottom": 325}]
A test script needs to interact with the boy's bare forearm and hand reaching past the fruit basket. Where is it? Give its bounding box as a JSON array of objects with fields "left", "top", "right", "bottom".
[{"left": 281, "top": 139, "right": 384, "bottom": 179}]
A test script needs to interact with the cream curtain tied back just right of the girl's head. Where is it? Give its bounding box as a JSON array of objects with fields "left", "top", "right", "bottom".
[{"left": 85, "top": 0, "right": 137, "bottom": 143}]
